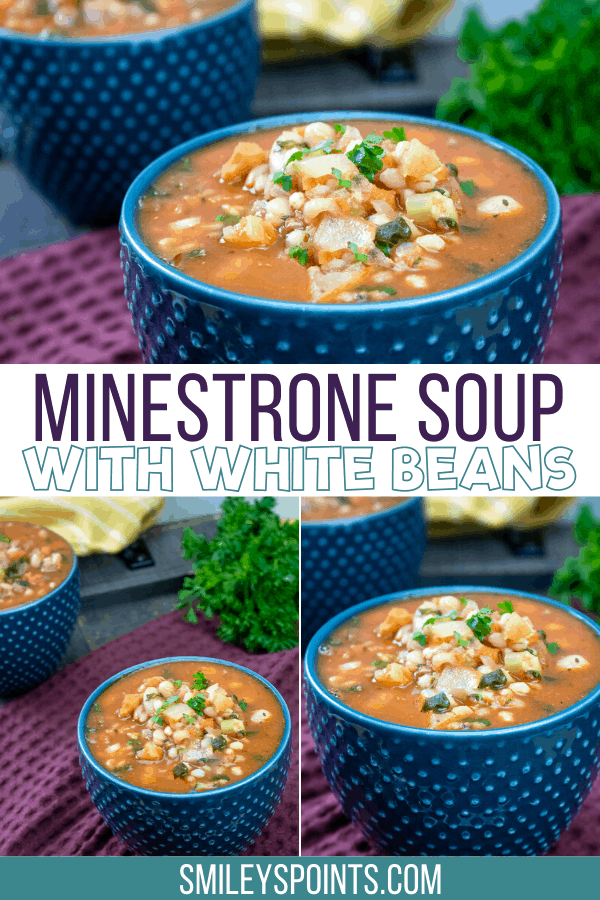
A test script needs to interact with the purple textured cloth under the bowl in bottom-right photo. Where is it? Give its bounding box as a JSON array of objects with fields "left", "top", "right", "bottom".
[{"left": 301, "top": 709, "right": 600, "bottom": 856}]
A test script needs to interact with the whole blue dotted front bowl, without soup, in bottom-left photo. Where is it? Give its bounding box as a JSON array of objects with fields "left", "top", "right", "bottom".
[{"left": 77, "top": 656, "right": 292, "bottom": 856}]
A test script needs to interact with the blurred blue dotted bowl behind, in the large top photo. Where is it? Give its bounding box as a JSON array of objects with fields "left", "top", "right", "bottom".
[{"left": 0, "top": 0, "right": 259, "bottom": 226}]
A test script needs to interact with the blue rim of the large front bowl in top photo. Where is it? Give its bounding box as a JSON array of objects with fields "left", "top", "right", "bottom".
[{"left": 120, "top": 111, "right": 561, "bottom": 318}]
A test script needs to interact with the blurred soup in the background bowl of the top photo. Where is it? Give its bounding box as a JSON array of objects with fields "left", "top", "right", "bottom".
[{"left": 0, "top": 0, "right": 235, "bottom": 38}]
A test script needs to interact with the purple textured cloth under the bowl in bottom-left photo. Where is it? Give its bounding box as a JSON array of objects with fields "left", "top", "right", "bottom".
[{"left": 0, "top": 612, "right": 299, "bottom": 856}]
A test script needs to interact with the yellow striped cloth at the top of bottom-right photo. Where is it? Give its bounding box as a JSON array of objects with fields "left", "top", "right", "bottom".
[{"left": 425, "top": 497, "right": 575, "bottom": 538}]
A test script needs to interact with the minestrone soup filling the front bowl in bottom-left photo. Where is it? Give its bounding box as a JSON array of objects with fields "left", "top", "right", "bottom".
[{"left": 86, "top": 661, "right": 285, "bottom": 794}]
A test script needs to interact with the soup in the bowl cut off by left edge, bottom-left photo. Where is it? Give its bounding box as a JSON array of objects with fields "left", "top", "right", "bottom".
[{"left": 0, "top": 521, "right": 73, "bottom": 610}]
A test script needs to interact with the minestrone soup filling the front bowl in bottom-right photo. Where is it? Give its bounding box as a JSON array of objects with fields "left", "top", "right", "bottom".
[{"left": 318, "top": 593, "right": 600, "bottom": 731}]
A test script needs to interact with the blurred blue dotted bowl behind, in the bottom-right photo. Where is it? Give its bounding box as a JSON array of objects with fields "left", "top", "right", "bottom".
[{"left": 300, "top": 497, "right": 427, "bottom": 648}]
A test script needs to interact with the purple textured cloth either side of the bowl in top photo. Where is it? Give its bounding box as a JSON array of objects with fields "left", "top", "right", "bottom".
[{"left": 0, "top": 194, "right": 600, "bottom": 363}]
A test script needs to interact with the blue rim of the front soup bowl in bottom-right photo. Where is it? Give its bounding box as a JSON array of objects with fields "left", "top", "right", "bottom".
[{"left": 304, "top": 584, "right": 600, "bottom": 742}]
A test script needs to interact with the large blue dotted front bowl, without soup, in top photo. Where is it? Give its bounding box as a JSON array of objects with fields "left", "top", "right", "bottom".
[{"left": 121, "top": 112, "right": 562, "bottom": 365}]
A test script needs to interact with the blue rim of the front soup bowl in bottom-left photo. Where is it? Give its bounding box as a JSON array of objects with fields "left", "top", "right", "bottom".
[{"left": 77, "top": 656, "right": 292, "bottom": 802}]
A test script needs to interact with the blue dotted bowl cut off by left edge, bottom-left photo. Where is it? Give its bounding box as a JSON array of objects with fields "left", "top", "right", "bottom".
[{"left": 0, "top": 540, "right": 81, "bottom": 697}]
